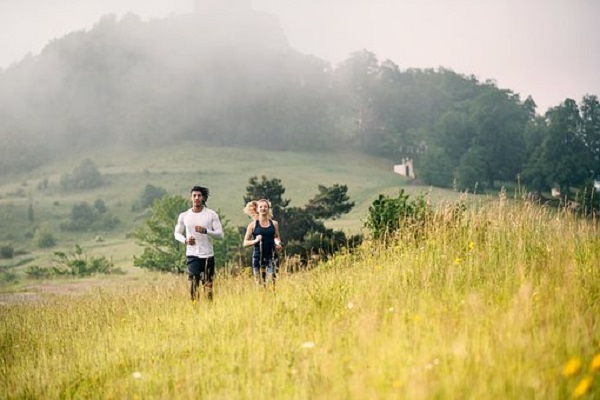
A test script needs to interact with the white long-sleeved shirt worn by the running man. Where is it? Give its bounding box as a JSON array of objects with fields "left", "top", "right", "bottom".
[{"left": 174, "top": 207, "right": 223, "bottom": 258}]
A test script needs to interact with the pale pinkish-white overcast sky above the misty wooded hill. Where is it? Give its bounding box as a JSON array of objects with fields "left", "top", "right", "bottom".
[{"left": 0, "top": 0, "right": 600, "bottom": 113}]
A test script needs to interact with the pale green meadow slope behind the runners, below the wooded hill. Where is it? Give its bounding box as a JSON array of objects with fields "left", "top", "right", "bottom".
[{"left": 0, "top": 143, "right": 458, "bottom": 291}]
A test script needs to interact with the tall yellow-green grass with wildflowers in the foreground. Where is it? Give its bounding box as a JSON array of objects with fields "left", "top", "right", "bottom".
[{"left": 0, "top": 197, "right": 600, "bottom": 399}]
